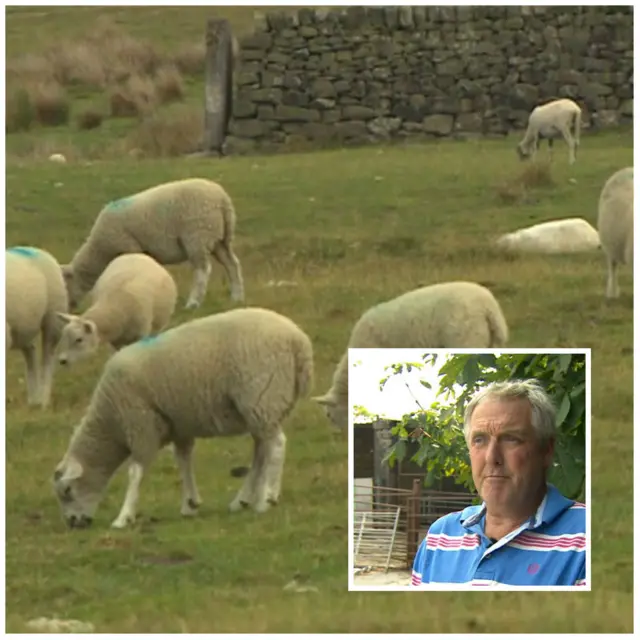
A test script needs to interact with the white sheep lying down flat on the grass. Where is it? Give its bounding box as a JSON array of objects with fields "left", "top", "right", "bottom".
[{"left": 496, "top": 218, "right": 600, "bottom": 253}]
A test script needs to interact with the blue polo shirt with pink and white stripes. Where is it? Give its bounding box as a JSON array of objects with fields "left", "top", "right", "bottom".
[{"left": 411, "top": 484, "right": 586, "bottom": 587}]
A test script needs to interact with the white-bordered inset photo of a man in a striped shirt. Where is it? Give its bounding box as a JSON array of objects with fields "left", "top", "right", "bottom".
[{"left": 349, "top": 348, "right": 591, "bottom": 591}]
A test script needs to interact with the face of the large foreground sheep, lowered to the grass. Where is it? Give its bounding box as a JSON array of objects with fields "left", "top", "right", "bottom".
[{"left": 53, "top": 456, "right": 102, "bottom": 529}]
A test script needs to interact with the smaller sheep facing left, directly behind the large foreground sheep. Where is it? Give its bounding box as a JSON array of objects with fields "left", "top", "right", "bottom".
[{"left": 58, "top": 253, "right": 178, "bottom": 365}]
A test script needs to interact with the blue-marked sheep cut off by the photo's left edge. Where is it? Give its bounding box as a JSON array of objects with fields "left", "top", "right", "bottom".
[{"left": 5, "top": 246, "right": 69, "bottom": 409}]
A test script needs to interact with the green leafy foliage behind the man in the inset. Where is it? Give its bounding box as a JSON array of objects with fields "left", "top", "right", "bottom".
[{"left": 380, "top": 354, "right": 586, "bottom": 499}]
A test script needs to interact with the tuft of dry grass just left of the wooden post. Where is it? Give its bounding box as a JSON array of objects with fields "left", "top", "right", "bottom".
[{"left": 126, "top": 105, "right": 204, "bottom": 158}]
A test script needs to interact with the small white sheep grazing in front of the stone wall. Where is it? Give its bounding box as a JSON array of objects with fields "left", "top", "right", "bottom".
[{"left": 517, "top": 98, "right": 582, "bottom": 164}]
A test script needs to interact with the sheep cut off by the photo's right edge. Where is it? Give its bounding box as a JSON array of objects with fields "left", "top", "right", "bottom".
[{"left": 598, "top": 167, "right": 633, "bottom": 298}]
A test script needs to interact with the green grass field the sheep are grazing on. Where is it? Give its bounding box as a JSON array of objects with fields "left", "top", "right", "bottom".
[{"left": 6, "top": 7, "right": 633, "bottom": 633}]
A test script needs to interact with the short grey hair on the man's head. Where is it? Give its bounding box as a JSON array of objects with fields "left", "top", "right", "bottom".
[{"left": 464, "top": 379, "right": 556, "bottom": 443}]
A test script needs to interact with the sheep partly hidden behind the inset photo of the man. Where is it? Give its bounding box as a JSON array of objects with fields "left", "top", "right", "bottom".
[{"left": 313, "top": 282, "right": 508, "bottom": 429}]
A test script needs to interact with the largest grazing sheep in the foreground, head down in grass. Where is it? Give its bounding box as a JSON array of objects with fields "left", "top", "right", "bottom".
[{"left": 53, "top": 307, "right": 313, "bottom": 528}]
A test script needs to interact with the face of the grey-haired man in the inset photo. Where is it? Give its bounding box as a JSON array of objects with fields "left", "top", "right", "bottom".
[{"left": 469, "top": 398, "right": 553, "bottom": 516}]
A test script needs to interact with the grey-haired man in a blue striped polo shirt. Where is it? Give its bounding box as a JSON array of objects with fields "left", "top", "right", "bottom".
[{"left": 412, "top": 380, "right": 586, "bottom": 586}]
